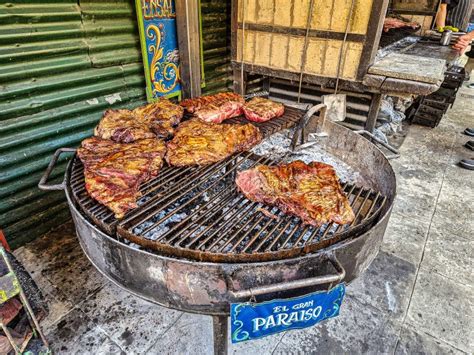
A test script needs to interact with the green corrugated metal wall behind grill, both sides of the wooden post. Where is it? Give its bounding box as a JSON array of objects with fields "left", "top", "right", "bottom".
[{"left": 0, "top": 0, "right": 230, "bottom": 247}]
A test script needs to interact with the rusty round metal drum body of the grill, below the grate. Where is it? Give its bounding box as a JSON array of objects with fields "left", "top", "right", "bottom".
[{"left": 66, "top": 118, "right": 396, "bottom": 315}]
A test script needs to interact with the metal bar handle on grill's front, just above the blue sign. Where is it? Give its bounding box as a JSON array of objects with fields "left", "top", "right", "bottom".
[{"left": 230, "top": 255, "right": 346, "bottom": 299}]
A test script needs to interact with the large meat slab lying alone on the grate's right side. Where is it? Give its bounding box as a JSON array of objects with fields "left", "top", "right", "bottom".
[{"left": 236, "top": 160, "right": 355, "bottom": 227}]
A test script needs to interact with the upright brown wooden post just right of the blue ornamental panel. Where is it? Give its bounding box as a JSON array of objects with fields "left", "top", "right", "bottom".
[{"left": 175, "top": 0, "right": 201, "bottom": 98}]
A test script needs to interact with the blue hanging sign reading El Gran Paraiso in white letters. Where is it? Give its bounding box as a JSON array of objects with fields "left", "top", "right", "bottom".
[{"left": 230, "top": 284, "right": 346, "bottom": 343}]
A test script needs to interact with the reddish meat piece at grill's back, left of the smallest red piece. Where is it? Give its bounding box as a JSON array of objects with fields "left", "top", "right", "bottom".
[{"left": 181, "top": 92, "right": 245, "bottom": 123}]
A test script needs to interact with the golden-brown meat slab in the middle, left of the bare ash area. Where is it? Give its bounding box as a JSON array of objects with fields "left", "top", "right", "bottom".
[{"left": 166, "top": 119, "right": 262, "bottom": 166}]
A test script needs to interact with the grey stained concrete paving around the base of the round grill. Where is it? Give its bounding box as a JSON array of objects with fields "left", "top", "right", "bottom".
[{"left": 15, "top": 82, "right": 474, "bottom": 354}]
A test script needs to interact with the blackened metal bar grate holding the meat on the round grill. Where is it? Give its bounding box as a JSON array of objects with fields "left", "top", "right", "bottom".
[{"left": 70, "top": 107, "right": 385, "bottom": 262}]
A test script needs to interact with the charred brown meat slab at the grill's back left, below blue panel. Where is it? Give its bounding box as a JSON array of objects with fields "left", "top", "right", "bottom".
[{"left": 94, "top": 99, "right": 184, "bottom": 143}]
